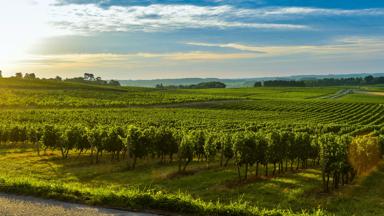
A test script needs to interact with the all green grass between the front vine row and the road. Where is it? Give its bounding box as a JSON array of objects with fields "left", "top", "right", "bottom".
[{"left": 0, "top": 148, "right": 384, "bottom": 215}]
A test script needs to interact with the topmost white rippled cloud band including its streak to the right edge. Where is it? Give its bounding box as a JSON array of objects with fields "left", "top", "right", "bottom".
[{"left": 45, "top": 4, "right": 384, "bottom": 34}]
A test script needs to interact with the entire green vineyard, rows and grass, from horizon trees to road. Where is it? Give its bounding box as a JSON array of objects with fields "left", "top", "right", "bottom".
[{"left": 0, "top": 79, "right": 384, "bottom": 215}]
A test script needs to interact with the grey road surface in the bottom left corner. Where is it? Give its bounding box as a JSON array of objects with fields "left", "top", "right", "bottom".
[{"left": 0, "top": 193, "right": 158, "bottom": 216}]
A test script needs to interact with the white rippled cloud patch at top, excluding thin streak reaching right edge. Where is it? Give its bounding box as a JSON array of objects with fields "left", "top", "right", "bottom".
[{"left": 50, "top": 4, "right": 309, "bottom": 33}]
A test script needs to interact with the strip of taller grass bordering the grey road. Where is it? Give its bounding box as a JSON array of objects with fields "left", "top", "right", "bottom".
[{"left": 0, "top": 176, "right": 323, "bottom": 215}]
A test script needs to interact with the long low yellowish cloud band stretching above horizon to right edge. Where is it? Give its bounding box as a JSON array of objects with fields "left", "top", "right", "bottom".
[{"left": 17, "top": 37, "right": 384, "bottom": 68}]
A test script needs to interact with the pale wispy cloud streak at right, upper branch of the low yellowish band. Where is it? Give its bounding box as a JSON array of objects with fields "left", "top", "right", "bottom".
[{"left": 185, "top": 37, "right": 384, "bottom": 56}]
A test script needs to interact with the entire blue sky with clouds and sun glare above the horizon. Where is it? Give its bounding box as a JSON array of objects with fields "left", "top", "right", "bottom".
[{"left": 0, "top": 0, "right": 384, "bottom": 80}]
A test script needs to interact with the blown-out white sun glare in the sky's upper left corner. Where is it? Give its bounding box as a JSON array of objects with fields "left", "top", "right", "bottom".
[{"left": 0, "top": 0, "right": 52, "bottom": 67}]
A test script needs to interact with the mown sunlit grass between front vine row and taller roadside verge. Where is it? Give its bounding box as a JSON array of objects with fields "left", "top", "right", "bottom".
[{"left": 0, "top": 148, "right": 384, "bottom": 215}]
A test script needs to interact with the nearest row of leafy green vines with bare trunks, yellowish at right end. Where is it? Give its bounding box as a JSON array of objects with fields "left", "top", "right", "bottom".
[{"left": 0, "top": 125, "right": 384, "bottom": 191}]
